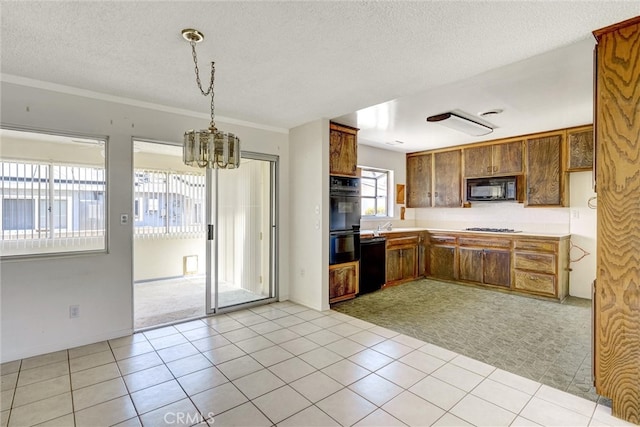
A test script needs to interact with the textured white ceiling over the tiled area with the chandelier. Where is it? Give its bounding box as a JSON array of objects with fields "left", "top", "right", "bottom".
[{"left": 1, "top": 1, "right": 640, "bottom": 151}]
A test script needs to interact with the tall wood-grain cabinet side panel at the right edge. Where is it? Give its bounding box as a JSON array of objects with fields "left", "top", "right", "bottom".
[{"left": 593, "top": 16, "right": 640, "bottom": 424}]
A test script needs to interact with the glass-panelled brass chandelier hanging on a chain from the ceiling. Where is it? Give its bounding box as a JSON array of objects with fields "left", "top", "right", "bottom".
[{"left": 182, "top": 29, "right": 240, "bottom": 169}]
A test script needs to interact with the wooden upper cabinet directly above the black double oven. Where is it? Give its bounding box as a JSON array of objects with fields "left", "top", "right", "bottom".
[{"left": 329, "top": 123, "right": 358, "bottom": 176}]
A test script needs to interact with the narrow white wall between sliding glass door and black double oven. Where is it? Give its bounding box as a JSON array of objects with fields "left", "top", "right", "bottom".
[{"left": 289, "top": 120, "right": 329, "bottom": 310}]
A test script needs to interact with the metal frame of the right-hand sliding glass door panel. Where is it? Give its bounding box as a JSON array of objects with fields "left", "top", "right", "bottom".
[{"left": 205, "top": 151, "right": 280, "bottom": 315}]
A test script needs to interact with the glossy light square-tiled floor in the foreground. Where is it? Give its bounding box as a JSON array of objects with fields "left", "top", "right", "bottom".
[{"left": 0, "top": 302, "right": 631, "bottom": 427}]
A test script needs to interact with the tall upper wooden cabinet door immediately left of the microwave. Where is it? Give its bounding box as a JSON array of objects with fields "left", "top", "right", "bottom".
[{"left": 433, "top": 150, "right": 462, "bottom": 207}]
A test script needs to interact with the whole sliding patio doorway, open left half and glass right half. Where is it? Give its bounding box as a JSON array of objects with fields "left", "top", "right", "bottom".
[{"left": 132, "top": 140, "right": 278, "bottom": 330}]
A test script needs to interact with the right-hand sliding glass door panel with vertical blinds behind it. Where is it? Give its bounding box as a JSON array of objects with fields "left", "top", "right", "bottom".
[{"left": 206, "top": 152, "right": 277, "bottom": 314}]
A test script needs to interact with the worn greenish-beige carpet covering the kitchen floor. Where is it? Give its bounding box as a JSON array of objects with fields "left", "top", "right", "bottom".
[{"left": 332, "top": 279, "right": 607, "bottom": 404}]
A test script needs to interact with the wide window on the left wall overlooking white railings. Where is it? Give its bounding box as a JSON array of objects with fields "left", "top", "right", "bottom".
[{"left": 0, "top": 129, "right": 106, "bottom": 257}]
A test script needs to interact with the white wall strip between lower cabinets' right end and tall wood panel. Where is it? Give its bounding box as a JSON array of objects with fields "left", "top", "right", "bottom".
[{"left": 569, "top": 171, "right": 597, "bottom": 299}]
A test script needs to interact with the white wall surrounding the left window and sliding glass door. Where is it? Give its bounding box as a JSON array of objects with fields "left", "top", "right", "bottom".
[{"left": 0, "top": 82, "right": 290, "bottom": 362}]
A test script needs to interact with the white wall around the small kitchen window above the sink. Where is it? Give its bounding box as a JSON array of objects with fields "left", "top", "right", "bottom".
[{"left": 358, "top": 144, "right": 415, "bottom": 230}]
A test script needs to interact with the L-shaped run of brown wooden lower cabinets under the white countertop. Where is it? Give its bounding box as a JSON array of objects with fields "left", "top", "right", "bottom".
[{"left": 383, "top": 231, "right": 569, "bottom": 301}]
